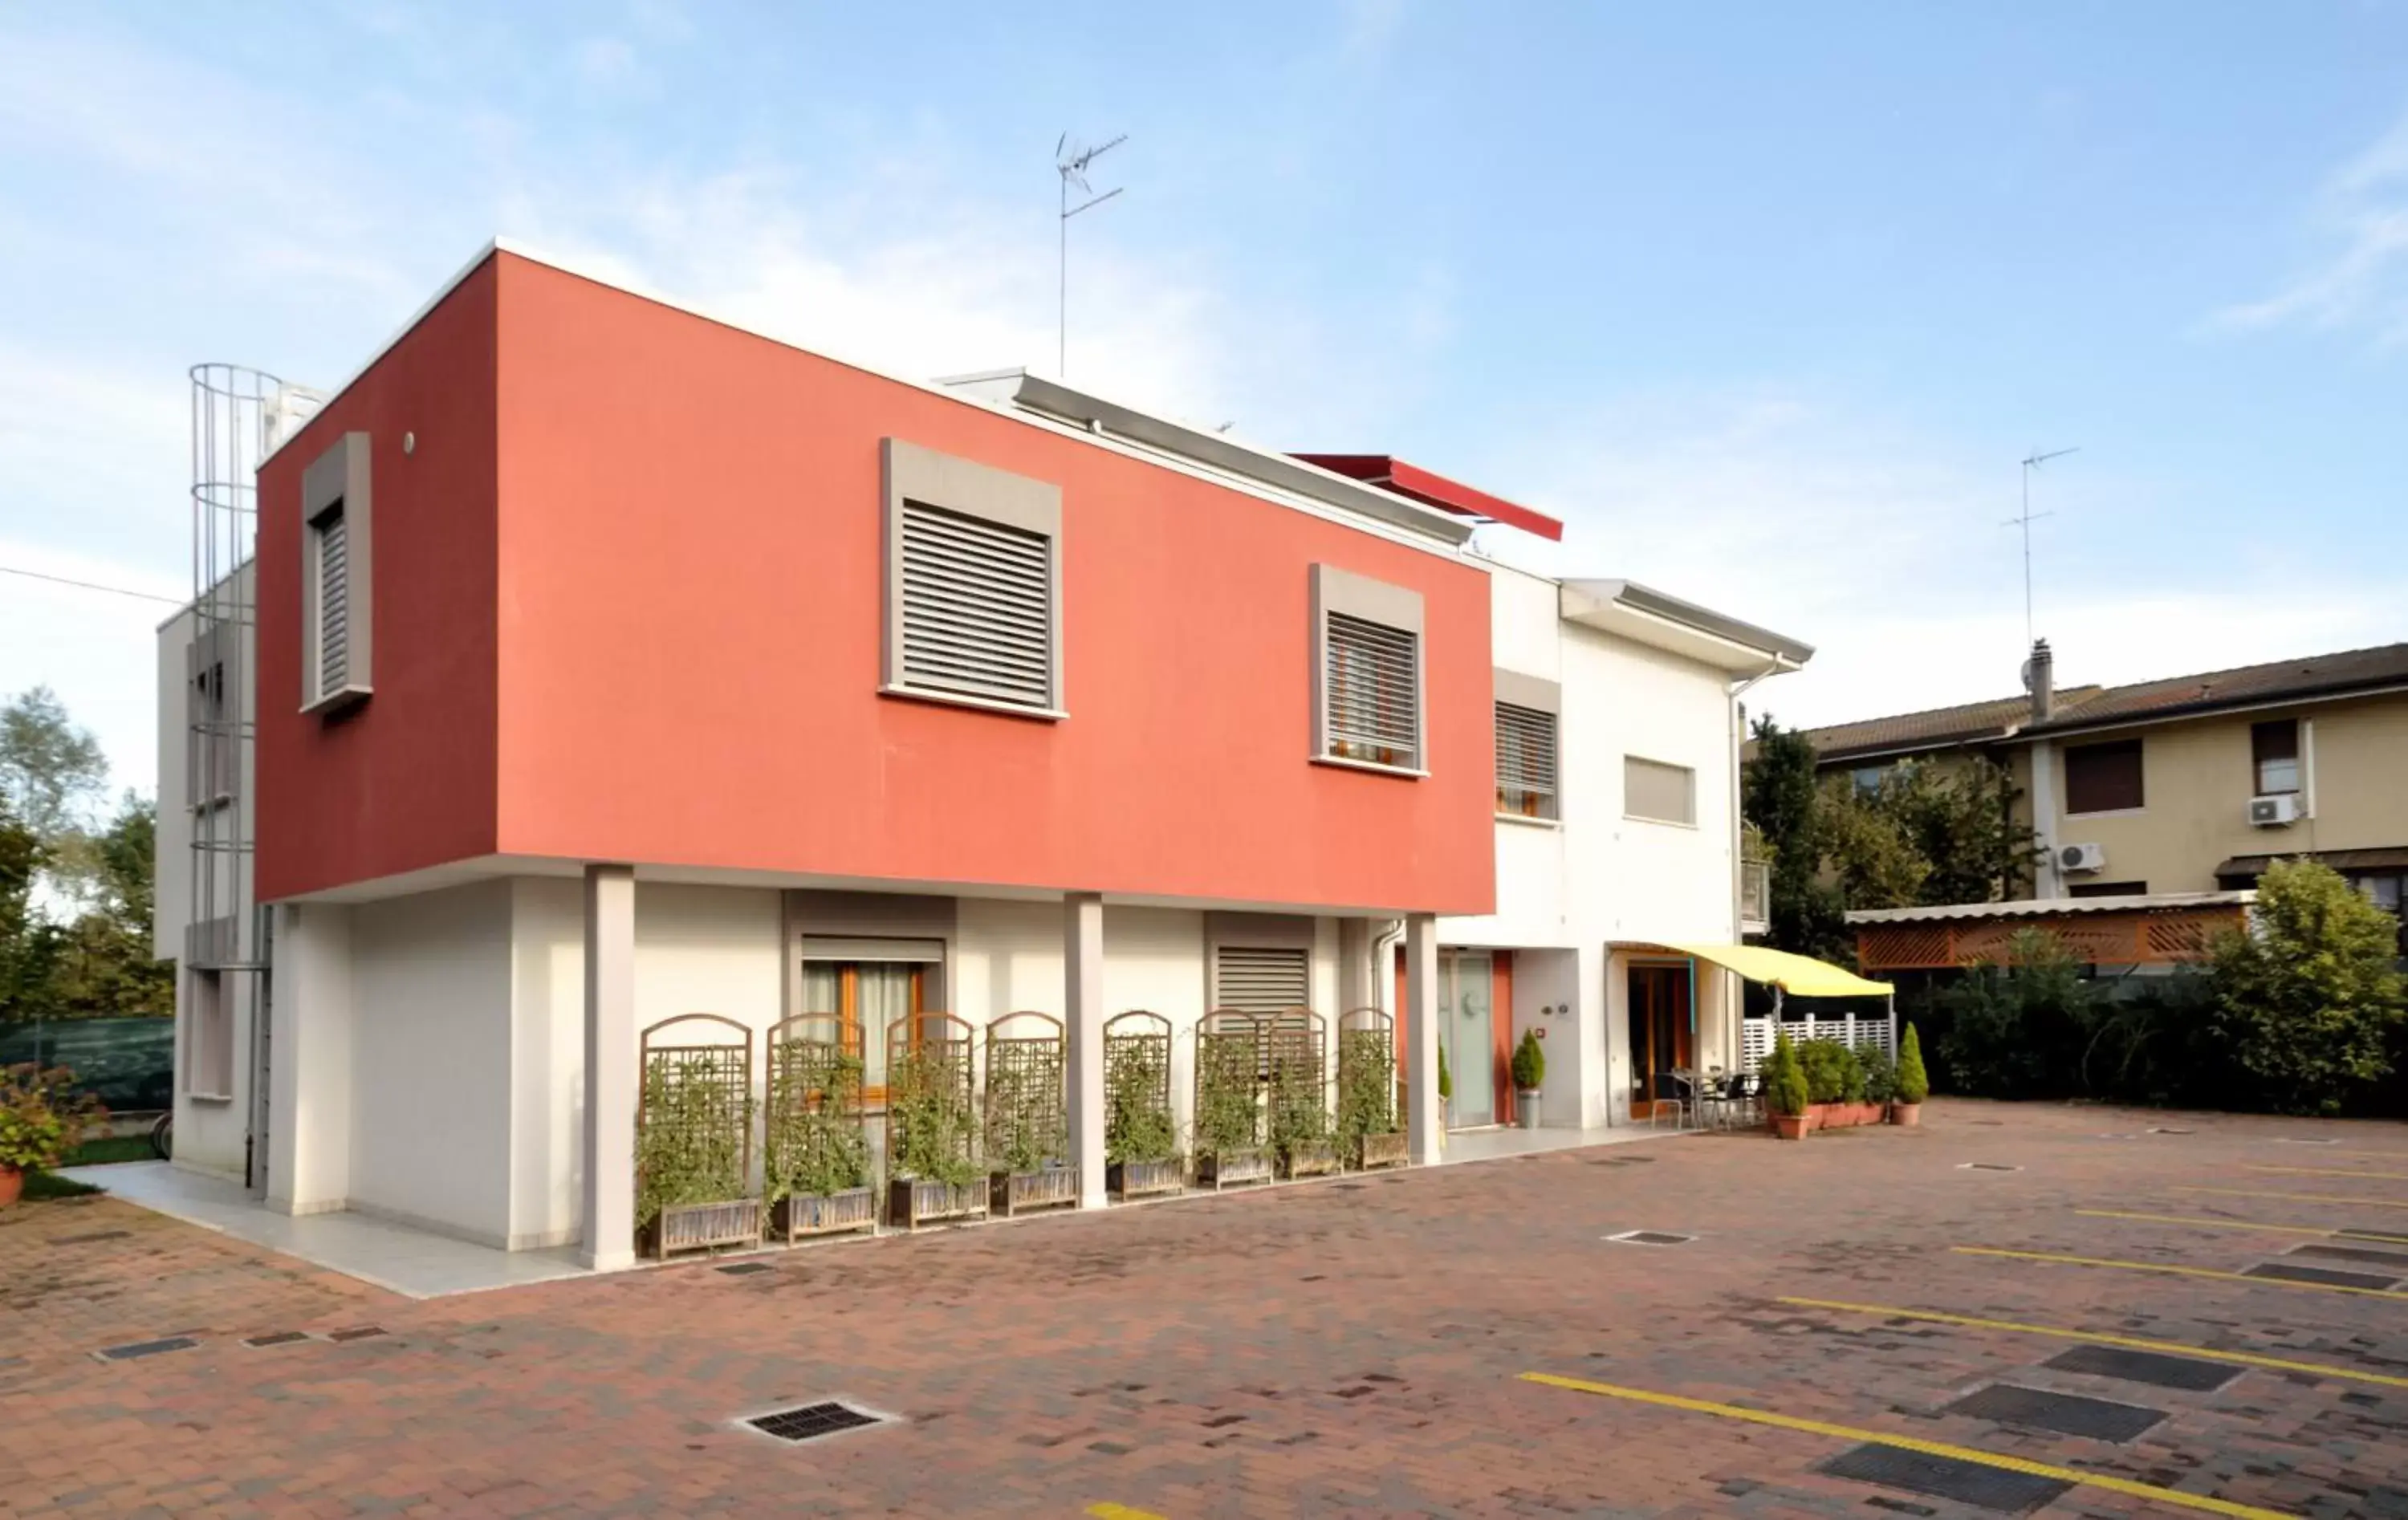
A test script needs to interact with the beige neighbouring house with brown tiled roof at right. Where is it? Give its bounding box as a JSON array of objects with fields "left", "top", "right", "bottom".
[{"left": 1806, "top": 638, "right": 2408, "bottom": 944}]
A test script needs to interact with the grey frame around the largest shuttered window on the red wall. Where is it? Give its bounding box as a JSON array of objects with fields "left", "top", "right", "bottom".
[{"left": 879, "top": 438, "right": 1069, "bottom": 720}]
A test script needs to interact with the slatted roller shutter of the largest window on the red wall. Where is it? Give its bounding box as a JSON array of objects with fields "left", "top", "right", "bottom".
[{"left": 901, "top": 501, "right": 1055, "bottom": 710}]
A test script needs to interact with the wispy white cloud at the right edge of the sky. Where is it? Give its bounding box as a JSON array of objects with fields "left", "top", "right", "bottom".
[{"left": 2213, "top": 116, "right": 2408, "bottom": 347}]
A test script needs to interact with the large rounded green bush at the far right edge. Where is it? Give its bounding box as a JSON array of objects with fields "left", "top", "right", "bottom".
[{"left": 2215, "top": 860, "right": 2408, "bottom": 1113}]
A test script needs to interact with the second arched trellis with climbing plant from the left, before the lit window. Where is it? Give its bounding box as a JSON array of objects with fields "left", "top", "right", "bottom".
[{"left": 761, "top": 1014, "right": 879, "bottom": 1241}]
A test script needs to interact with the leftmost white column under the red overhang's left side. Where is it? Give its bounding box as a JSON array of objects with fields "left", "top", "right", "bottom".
[{"left": 270, "top": 904, "right": 352, "bottom": 1214}]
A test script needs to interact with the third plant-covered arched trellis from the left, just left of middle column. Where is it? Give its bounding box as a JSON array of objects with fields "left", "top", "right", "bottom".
[{"left": 886, "top": 1012, "right": 987, "bottom": 1229}]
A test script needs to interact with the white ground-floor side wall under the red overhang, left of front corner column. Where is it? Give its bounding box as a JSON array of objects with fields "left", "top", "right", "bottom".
[{"left": 349, "top": 882, "right": 513, "bottom": 1246}]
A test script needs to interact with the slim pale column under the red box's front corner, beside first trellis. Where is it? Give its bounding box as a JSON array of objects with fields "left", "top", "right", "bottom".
[{"left": 578, "top": 865, "right": 638, "bottom": 1272}]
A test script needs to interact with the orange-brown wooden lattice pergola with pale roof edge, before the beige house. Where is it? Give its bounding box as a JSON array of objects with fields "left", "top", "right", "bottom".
[{"left": 1847, "top": 892, "right": 2256, "bottom": 973}]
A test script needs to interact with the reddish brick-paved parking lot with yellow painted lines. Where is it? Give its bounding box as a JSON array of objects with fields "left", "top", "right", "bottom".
[{"left": 0, "top": 1103, "right": 2408, "bottom": 1520}]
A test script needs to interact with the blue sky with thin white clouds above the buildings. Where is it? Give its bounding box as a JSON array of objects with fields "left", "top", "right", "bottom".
[{"left": 0, "top": 0, "right": 2408, "bottom": 786}]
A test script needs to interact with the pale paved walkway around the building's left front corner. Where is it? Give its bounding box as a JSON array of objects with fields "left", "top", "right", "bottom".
[{"left": 58, "top": 1161, "right": 585, "bottom": 1299}]
